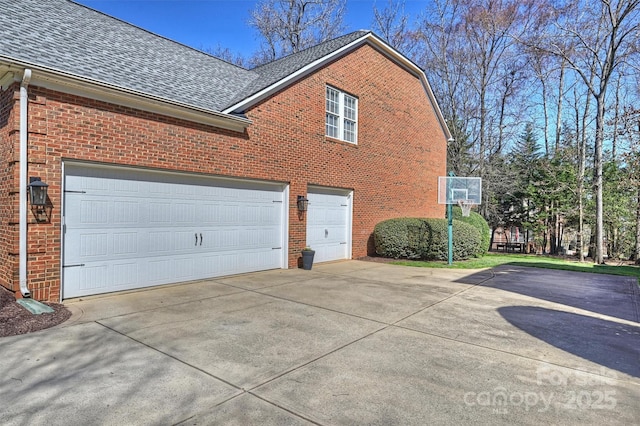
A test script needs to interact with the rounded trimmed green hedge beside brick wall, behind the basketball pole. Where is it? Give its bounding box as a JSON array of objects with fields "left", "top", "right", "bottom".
[{"left": 373, "top": 218, "right": 482, "bottom": 260}]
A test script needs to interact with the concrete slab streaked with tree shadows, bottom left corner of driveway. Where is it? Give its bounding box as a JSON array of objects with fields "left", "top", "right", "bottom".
[{"left": 0, "top": 323, "right": 240, "bottom": 425}]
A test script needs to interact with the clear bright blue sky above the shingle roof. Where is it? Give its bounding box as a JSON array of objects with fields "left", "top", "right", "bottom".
[{"left": 75, "top": 0, "right": 430, "bottom": 57}]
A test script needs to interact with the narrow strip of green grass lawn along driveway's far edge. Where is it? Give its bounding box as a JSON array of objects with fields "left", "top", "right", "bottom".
[{"left": 392, "top": 253, "right": 640, "bottom": 283}]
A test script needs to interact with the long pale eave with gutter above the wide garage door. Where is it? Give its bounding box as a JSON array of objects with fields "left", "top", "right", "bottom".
[{"left": 0, "top": 56, "right": 251, "bottom": 133}]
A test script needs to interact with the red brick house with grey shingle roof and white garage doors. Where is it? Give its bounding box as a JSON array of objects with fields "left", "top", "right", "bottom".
[{"left": 0, "top": 0, "right": 450, "bottom": 301}]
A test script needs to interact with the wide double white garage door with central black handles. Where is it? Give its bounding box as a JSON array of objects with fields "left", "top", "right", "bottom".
[{"left": 63, "top": 165, "right": 286, "bottom": 298}]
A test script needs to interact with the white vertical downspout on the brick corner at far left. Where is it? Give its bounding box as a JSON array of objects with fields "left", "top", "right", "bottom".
[{"left": 19, "top": 69, "right": 31, "bottom": 297}]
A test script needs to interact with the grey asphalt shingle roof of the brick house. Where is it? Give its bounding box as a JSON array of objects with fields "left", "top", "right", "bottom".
[{"left": 0, "top": 0, "right": 367, "bottom": 112}]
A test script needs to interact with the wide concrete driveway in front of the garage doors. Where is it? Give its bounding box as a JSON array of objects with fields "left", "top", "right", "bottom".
[{"left": 0, "top": 261, "right": 640, "bottom": 426}]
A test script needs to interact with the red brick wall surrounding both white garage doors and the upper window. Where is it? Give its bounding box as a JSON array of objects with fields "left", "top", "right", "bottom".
[{"left": 0, "top": 46, "right": 446, "bottom": 300}]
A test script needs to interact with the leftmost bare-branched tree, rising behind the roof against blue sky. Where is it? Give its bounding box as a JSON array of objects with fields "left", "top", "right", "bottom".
[{"left": 249, "top": 0, "right": 346, "bottom": 66}]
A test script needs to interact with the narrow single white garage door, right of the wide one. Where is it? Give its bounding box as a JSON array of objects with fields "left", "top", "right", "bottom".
[{"left": 307, "top": 187, "right": 352, "bottom": 262}]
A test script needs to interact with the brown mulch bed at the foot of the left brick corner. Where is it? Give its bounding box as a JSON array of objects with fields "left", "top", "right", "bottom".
[{"left": 0, "top": 287, "right": 71, "bottom": 337}]
